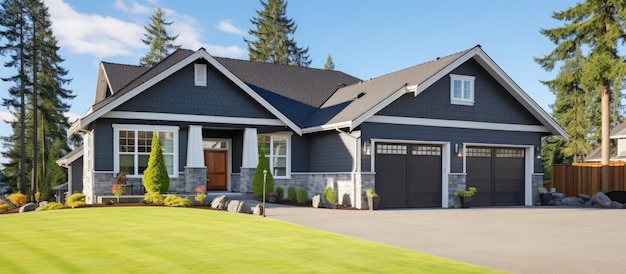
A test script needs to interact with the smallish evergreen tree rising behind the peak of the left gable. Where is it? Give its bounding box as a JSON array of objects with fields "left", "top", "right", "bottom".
[{"left": 139, "top": 7, "right": 181, "bottom": 67}]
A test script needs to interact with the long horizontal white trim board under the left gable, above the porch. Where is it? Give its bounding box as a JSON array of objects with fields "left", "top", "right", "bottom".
[{"left": 102, "top": 111, "right": 286, "bottom": 126}]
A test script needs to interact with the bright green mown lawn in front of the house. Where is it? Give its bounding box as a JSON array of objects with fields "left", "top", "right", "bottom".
[{"left": 0, "top": 206, "right": 494, "bottom": 273}]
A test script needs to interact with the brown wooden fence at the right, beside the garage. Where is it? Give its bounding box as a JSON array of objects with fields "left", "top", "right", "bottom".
[{"left": 546, "top": 162, "right": 626, "bottom": 196}]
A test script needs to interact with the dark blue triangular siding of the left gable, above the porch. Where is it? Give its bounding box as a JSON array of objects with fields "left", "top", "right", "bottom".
[{"left": 115, "top": 64, "right": 275, "bottom": 118}]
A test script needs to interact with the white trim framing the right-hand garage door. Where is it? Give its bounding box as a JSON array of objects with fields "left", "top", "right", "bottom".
[{"left": 463, "top": 143, "right": 535, "bottom": 206}]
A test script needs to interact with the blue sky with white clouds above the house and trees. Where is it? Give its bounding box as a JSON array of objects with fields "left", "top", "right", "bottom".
[{"left": 0, "top": 0, "right": 577, "bottom": 166}]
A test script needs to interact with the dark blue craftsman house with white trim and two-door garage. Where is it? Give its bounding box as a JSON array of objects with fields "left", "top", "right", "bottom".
[{"left": 64, "top": 46, "right": 566, "bottom": 208}]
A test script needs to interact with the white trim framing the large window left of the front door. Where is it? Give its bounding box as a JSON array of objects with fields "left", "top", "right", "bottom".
[{"left": 111, "top": 124, "right": 180, "bottom": 178}]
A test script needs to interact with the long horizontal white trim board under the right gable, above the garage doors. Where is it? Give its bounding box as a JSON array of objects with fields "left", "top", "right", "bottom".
[{"left": 367, "top": 115, "right": 549, "bottom": 132}]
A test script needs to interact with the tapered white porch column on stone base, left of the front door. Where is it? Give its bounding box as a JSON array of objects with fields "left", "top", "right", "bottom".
[{"left": 185, "top": 126, "right": 207, "bottom": 193}]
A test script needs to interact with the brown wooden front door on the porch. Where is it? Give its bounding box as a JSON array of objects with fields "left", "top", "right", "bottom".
[{"left": 204, "top": 150, "right": 228, "bottom": 190}]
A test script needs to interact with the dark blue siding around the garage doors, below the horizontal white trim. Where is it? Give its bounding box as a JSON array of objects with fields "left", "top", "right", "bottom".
[{"left": 361, "top": 123, "right": 542, "bottom": 173}]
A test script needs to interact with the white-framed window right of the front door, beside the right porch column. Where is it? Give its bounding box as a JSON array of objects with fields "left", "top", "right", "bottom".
[{"left": 259, "top": 134, "right": 291, "bottom": 178}]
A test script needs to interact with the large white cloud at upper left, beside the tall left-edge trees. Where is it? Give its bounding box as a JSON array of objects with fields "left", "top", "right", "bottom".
[{"left": 46, "top": 0, "right": 144, "bottom": 59}]
